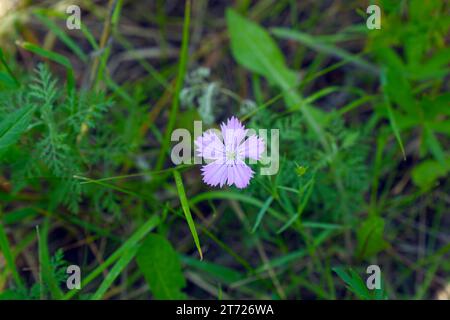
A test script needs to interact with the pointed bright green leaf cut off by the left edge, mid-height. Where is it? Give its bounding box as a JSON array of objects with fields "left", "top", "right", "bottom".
[{"left": 0, "top": 106, "right": 34, "bottom": 156}]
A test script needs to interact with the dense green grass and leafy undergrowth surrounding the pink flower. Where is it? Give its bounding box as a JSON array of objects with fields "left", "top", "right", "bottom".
[{"left": 0, "top": 0, "right": 450, "bottom": 299}]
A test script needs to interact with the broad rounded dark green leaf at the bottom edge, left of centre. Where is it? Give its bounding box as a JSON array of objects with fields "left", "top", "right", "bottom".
[{"left": 136, "top": 234, "right": 186, "bottom": 300}]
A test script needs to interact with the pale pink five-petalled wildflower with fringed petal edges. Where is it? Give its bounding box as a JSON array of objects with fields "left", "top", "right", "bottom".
[{"left": 195, "top": 117, "right": 265, "bottom": 189}]
